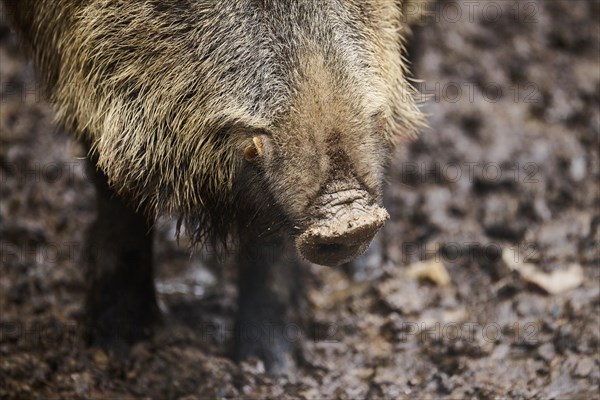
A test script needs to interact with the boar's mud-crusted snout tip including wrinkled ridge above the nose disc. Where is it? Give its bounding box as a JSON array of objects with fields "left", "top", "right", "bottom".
[{"left": 296, "top": 189, "right": 389, "bottom": 266}]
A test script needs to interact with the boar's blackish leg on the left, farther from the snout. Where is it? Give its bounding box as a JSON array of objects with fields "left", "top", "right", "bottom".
[{"left": 83, "top": 155, "right": 159, "bottom": 355}]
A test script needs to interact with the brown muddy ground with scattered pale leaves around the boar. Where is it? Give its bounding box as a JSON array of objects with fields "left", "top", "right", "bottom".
[{"left": 0, "top": 0, "right": 600, "bottom": 399}]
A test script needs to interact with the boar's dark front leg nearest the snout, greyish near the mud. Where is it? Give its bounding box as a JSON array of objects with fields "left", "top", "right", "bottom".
[{"left": 235, "top": 234, "right": 302, "bottom": 375}]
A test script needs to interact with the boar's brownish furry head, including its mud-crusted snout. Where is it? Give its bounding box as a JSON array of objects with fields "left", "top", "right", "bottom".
[{"left": 224, "top": 7, "right": 422, "bottom": 266}]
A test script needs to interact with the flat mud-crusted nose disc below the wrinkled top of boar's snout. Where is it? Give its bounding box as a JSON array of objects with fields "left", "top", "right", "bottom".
[{"left": 296, "top": 205, "right": 389, "bottom": 266}]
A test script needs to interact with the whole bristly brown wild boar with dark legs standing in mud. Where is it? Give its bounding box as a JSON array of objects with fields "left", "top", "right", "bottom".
[{"left": 4, "top": 0, "right": 423, "bottom": 373}]
